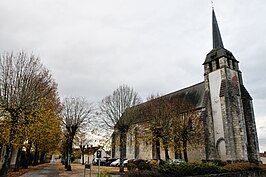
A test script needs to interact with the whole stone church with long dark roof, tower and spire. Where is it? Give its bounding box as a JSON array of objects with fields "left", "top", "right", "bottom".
[{"left": 112, "top": 10, "right": 260, "bottom": 162}]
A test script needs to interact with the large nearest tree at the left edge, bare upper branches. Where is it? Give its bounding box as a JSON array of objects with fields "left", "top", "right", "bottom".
[{"left": 0, "top": 52, "right": 56, "bottom": 176}]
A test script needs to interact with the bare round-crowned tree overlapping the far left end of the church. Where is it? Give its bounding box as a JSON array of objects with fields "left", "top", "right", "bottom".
[{"left": 100, "top": 85, "right": 142, "bottom": 171}]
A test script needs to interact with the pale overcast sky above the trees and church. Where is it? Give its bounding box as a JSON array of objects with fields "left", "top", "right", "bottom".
[{"left": 0, "top": 0, "right": 266, "bottom": 152}]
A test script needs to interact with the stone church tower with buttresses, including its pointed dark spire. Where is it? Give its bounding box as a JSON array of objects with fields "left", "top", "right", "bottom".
[{"left": 203, "top": 9, "right": 260, "bottom": 162}]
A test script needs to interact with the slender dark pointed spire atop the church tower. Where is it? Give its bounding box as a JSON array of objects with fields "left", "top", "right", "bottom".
[{"left": 212, "top": 8, "right": 224, "bottom": 49}]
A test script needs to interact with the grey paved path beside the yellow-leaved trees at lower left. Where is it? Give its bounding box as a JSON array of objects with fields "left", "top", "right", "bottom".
[{"left": 21, "top": 164, "right": 59, "bottom": 177}]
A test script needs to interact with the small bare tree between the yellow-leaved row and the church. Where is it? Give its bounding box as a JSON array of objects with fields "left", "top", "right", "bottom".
[{"left": 61, "top": 97, "right": 94, "bottom": 171}]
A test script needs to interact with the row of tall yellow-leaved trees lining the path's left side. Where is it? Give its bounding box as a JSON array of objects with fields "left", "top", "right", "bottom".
[{"left": 0, "top": 52, "right": 61, "bottom": 176}]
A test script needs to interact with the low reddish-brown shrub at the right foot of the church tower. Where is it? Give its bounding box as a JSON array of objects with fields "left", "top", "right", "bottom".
[{"left": 223, "top": 162, "right": 261, "bottom": 172}]
